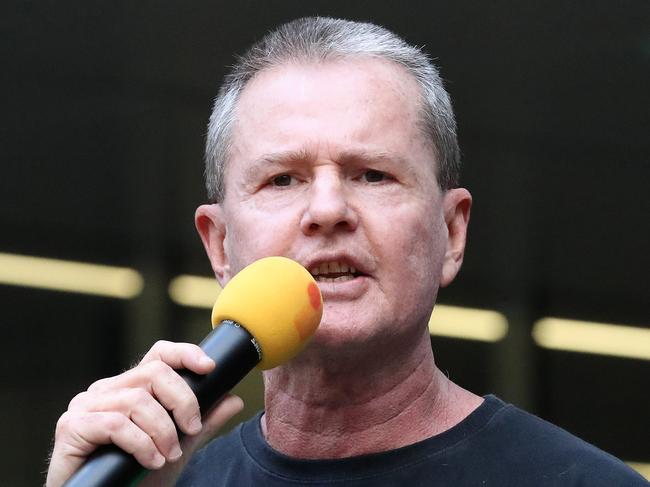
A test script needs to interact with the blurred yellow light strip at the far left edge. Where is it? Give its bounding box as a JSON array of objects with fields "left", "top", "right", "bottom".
[{"left": 0, "top": 253, "right": 144, "bottom": 299}]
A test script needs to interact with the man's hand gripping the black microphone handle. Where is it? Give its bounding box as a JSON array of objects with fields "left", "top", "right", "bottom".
[{"left": 46, "top": 341, "right": 243, "bottom": 487}]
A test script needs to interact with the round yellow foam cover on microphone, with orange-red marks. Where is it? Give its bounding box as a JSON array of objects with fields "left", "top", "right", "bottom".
[{"left": 212, "top": 257, "right": 323, "bottom": 370}]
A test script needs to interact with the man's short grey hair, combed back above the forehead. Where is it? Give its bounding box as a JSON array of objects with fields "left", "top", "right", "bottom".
[{"left": 205, "top": 17, "right": 460, "bottom": 202}]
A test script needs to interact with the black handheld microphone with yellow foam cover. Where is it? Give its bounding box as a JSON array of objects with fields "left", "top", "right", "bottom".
[{"left": 64, "top": 257, "right": 323, "bottom": 487}]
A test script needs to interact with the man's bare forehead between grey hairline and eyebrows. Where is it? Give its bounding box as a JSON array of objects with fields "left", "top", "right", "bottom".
[{"left": 231, "top": 58, "right": 426, "bottom": 165}]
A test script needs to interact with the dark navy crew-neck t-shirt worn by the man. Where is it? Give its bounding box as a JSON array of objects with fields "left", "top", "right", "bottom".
[{"left": 177, "top": 396, "right": 650, "bottom": 487}]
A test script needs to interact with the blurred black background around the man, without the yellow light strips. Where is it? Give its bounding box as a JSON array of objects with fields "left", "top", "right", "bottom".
[{"left": 0, "top": 0, "right": 650, "bottom": 486}]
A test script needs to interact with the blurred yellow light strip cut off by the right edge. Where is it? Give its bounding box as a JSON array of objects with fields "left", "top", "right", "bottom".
[{"left": 533, "top": 318, "right": 650, "bottom": 360}]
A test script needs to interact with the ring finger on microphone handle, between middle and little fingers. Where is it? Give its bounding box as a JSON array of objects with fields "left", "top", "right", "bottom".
[{"left": 68, "top": 388, "right": 182, "bottom": 461}]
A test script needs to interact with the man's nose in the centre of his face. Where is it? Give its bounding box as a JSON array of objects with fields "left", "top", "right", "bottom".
[{"left": 300, "top": 171, "right": 359, "bottom": 235}]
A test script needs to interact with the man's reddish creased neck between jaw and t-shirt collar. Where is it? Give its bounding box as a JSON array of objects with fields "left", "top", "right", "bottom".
[{"left": 262, "top": 333, "right": 482, "bottom": 459}]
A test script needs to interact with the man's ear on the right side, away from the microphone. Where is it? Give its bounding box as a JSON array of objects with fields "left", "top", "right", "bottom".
[{"left": 440, "top": 188, "right": 472, "bottom": 287}]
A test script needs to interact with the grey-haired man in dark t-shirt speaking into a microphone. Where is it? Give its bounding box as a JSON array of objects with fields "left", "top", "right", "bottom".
[{"left": 48, "top": 18, "right": 647, "bottom": 486}]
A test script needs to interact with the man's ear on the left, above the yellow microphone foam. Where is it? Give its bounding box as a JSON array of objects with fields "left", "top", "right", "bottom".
[{"left": 194, "top": 204, "right": 232, "bottom": 287}]
